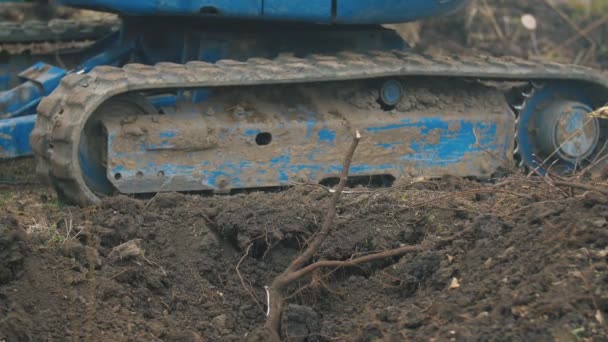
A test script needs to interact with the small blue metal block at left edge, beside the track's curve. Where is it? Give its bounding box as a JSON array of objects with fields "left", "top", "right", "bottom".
[{"left": 0, "top": 115, "right": 36, "bottom": 159}]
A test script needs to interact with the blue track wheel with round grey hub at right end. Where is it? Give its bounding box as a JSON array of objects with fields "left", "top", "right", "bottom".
[{"left": 516, "top": 84, "right": 608, "bottom": 174}]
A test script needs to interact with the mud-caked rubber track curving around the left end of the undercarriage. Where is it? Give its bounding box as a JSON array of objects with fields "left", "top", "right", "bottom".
[{"left": 31, "top": 51, "right": 608, "bottom": 205}]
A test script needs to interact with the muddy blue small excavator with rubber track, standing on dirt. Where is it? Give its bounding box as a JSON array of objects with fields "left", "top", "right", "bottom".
[{"left": 0, "top": 0, "right": 608, "bottom": 205}]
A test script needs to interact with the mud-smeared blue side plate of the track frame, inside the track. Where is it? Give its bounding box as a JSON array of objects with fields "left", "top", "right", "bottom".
[{"left": 104, "top": 85, "right": 514, "bottom": 193}]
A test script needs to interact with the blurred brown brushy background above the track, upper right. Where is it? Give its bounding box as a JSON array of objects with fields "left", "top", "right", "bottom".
[{"left": 394, "top": 0, "right": 608, "bottom": 68}]
